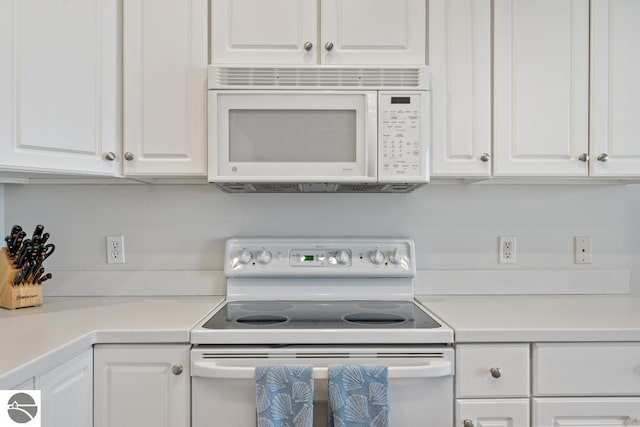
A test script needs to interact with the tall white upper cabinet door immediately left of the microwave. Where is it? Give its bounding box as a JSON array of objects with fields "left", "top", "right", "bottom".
[{"left": 123, "top": 0, "right": 208, "bottom": 176}]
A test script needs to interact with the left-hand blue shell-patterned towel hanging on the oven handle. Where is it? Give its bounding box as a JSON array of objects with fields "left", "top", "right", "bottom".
[{"left": 255, "top": 365, "right": 313, "bottom": 427}]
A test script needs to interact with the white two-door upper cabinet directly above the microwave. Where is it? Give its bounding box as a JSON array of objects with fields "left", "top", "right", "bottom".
[{"left": 211, "top": 0, "right": 427, "bottom": 65}]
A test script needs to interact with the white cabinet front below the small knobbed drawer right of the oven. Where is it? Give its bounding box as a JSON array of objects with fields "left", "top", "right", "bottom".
[{"left": 456, "top": 399, "right": 529, "bottom": 427}]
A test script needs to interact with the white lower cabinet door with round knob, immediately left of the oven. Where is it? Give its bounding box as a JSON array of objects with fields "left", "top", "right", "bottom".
[{"left": 93, "top": 344, "right": 191, "bottom": 427}]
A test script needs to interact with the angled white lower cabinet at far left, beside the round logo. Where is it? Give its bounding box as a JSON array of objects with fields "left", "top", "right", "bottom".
[{"left": 38, "top": 349, "right": 93, "bottom": 427}]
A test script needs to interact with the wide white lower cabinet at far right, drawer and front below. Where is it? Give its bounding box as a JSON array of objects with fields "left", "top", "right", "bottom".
[{"left": 532, "top": 343, "right": 640, "bottom": 427}]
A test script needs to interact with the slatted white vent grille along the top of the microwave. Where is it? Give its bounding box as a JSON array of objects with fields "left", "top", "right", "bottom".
[{"left": 209, "top": 66, "right": 429, "bottom": 90}]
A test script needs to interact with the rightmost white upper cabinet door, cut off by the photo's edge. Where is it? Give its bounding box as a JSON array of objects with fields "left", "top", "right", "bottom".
[{"left": 590, "top": 0, "right": 640, "bottom": 176}]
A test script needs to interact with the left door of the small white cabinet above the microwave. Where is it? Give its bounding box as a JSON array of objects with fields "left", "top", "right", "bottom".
[{"left": 211, "top": 0, "right": 318, "bottom": 65}]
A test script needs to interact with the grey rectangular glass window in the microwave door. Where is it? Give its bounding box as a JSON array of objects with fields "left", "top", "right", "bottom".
[{"left": 229, "top": 109, "right": 357, "bottom": 163}]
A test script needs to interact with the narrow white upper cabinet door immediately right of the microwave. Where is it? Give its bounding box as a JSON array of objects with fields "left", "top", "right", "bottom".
[{"left": 429, "top": 0, "right": 491, "bottom": 177}]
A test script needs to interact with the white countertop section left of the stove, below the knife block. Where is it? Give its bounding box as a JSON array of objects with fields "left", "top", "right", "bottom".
[{"left": 0, "top": 296, "right": 223, "bottom": 389}]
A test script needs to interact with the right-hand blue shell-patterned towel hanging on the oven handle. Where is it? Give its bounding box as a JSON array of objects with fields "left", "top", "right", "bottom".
[{"left": 329, "top": 365, "right": 389, "bottom": 427}]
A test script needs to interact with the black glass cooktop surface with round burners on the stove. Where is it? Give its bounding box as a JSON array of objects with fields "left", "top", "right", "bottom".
[{"left": 202, "top": 300, "right": 441, "bottom": 330}]
